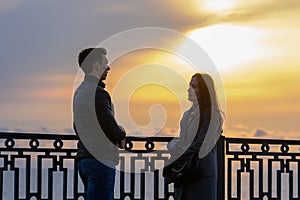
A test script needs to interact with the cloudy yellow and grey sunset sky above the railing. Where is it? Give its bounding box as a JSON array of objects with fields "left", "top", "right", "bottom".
[{"left": 0, "top": 0, "right": 300, "bottom": 139}]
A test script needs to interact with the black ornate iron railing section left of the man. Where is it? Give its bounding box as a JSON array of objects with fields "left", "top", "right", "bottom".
[{"left": 0, "top": 133, "right": 84, "bottom": 200}]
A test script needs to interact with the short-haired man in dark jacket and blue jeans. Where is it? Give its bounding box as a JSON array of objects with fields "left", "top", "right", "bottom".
[{"left": 73, "top": 48, "right": 126, "bottom": 200}]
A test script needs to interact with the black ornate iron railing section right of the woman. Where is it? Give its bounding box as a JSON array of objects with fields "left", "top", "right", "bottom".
[{"left": 225, "top": 138, "right": 300, "bottom": 200}]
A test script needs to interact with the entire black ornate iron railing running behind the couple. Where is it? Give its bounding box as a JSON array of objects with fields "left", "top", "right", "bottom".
[{"left": 0, "top": 133, "right": 300, "bottom": 200}]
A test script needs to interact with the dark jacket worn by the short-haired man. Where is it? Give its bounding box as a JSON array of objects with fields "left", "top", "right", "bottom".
[{"left": 73, "top": 75, "right": 125, "bottom": 165}]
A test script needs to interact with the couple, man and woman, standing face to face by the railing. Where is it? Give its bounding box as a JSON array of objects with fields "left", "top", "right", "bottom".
[{"left": 73, "top": 48, "right": 223, "bottom": 200}]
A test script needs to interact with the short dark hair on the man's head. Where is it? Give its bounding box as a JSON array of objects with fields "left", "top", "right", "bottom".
[{"left": 78, "top": 48, "right": 107, "bottom": 74}]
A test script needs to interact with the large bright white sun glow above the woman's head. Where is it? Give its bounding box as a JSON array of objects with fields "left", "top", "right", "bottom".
[{"left": 180, "top": 25, "right": 263, "bottom": 71}]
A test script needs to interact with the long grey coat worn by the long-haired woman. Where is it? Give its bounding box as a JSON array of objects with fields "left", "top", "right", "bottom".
[{"left": 168, "top": 106, "right": 218, "bottom": 200}]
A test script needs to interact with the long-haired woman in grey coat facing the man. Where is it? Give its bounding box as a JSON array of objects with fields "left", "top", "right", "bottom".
[{"left": 168, "top": 73, "right": 223, "bottom": 200}]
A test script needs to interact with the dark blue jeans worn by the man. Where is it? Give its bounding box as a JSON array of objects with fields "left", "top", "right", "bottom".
[{"left": 77, "top": 158, "right": 116, "bottom": 200}]
